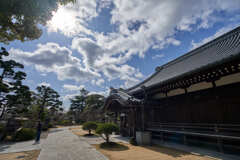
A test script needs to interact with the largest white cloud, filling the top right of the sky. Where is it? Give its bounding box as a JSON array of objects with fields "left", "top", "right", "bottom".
[{"left": 105, "top": 0, "right": 240, "bottom": 57}]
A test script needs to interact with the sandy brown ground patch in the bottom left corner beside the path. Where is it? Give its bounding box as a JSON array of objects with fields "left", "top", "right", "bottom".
[{"left": 0, "top": 150, "right": 40, "bottom": 160}]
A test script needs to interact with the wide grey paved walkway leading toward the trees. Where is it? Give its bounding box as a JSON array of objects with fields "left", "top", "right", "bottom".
[{"left": 38, "top": 128, "right": 108, "bottom": 160}]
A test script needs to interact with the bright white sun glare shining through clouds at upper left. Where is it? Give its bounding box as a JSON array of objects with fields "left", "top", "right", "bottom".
[{"left": 49, "top": 7, "right": 76, "bottom": 30}]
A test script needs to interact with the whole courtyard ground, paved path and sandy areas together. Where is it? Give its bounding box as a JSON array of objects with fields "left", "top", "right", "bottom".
[{"left": 0, "top": 126, "right": 239, "bottom": 160}]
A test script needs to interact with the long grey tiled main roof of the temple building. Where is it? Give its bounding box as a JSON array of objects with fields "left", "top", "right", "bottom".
[{"left": 127, "top": 27, "right": 240, "bottom": 93}]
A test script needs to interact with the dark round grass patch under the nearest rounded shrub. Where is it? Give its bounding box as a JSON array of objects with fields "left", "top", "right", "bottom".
[{"left": 99, "top": 142, "right": 129, "bottom": 151}]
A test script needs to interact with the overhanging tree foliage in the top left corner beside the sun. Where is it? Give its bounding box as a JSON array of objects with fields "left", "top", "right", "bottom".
[{"left": 0, "top": 0, "right": 75, "bottom": 43}]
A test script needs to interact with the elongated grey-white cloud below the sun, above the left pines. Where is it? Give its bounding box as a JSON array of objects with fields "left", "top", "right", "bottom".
[{"left": 9, "top": 43, "right": 100, "bottom": 82}]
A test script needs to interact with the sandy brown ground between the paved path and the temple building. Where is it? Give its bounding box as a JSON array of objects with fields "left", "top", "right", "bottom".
[{"left": 93, "top": 143, "right": 217, "bottom": 160}]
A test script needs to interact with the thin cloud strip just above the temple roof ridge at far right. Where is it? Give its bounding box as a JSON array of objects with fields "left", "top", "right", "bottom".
[{"left": 191, "top": 25, "right": 237, "bottom": 49}]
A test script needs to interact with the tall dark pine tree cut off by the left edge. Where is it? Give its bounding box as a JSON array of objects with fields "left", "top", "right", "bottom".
[{"left": 0, "top": 48, "right": 31, "bottom": 119}]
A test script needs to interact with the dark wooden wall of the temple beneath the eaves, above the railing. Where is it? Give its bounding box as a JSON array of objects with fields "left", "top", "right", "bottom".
[{"left": 146, "top": 83, "right": 240, "bottom": 124}]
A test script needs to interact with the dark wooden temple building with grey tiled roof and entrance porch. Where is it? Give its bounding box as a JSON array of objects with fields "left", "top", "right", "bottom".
[{"left": 104, "top": 27, "right": 240, "bottom": 152}]
